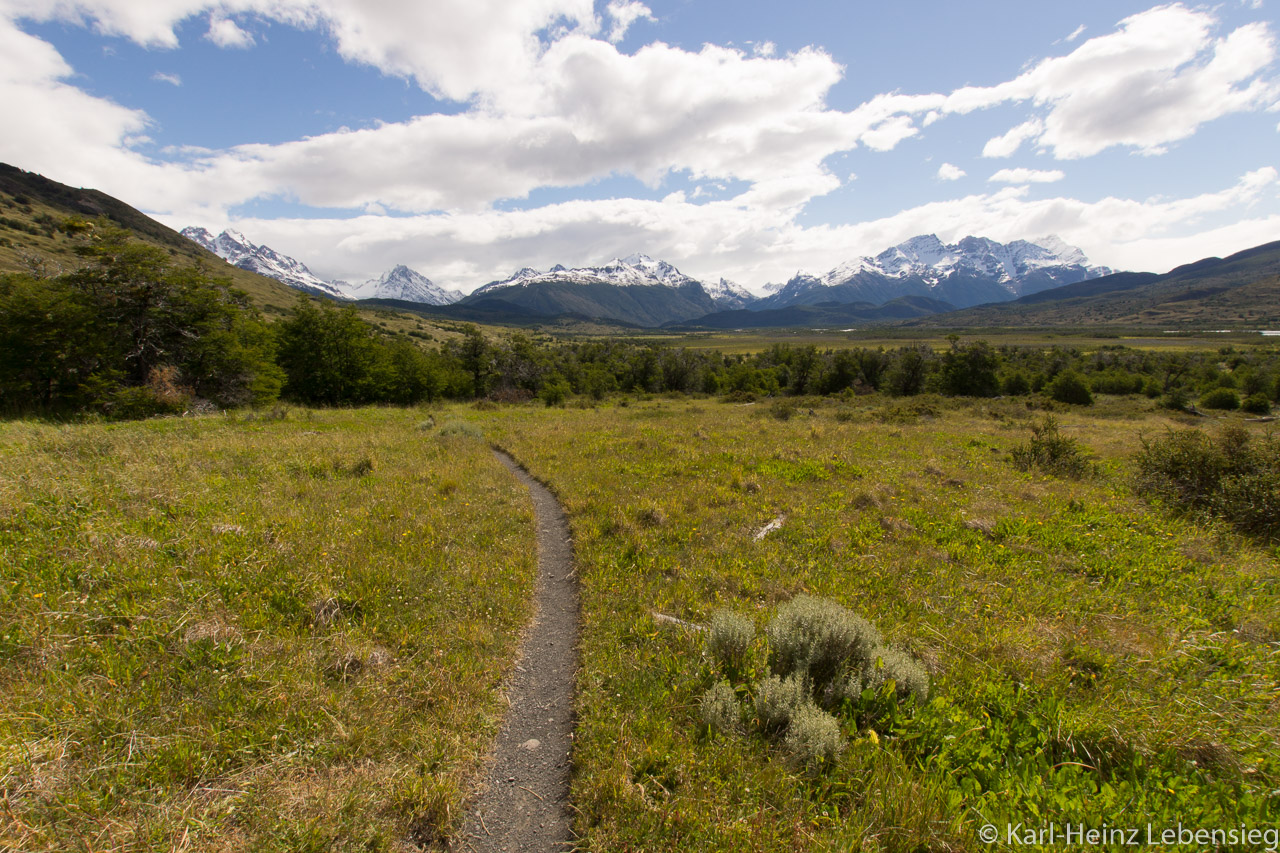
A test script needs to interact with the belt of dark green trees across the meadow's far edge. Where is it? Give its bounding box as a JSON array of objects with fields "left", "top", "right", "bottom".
[{"left": 0, "top": 227, "right": 1280, "bottom": 418}]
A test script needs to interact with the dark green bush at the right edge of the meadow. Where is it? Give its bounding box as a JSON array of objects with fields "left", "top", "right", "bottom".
[{"left": 1135, "top": 427, "right": 1280, "bottom": 539}]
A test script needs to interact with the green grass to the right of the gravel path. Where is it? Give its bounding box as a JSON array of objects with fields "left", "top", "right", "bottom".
[{"left": 486, "top": 397, "right": 1280, "bottom": 850}]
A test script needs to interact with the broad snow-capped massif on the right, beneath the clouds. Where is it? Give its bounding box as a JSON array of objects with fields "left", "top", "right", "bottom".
[{"left": 753, "top": 234, "right": 1111, "bottom": 309}]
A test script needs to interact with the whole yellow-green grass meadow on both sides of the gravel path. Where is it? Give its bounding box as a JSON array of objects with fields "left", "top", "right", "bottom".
[{"left": 0, "top": 396, "right": 1280, "bottom": 853}]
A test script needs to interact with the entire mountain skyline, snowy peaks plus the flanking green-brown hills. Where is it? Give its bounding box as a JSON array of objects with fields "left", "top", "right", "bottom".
[{"left": 0, "top": 164, "right": 1280, "bottom": 330}]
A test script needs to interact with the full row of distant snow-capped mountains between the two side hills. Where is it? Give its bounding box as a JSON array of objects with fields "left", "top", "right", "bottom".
[{"left": 182, "top": 220, "right": 1111, "bottom": 328}]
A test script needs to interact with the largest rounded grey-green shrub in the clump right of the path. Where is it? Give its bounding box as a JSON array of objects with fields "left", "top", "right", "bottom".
[{"left": 767, "top": 596, "right": 881, "bottom": 695}]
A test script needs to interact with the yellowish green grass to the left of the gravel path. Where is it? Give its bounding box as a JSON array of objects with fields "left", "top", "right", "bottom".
[{"left": 0, "top": 410, "right": 535, "bottom": 850}]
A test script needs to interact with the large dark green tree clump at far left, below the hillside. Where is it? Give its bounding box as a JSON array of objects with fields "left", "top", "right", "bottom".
[{"left": 0, "top": 224, "right": 280, "bottom": 416}]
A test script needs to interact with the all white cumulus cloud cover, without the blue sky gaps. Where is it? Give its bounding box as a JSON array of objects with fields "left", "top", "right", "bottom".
[{"left": 0, "top": 0, "right": 1280, "bottom": 288}]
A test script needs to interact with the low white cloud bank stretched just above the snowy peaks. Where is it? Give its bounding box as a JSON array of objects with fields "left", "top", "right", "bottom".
[{"left": 189, "top": 168, "right": 1280, "bottom": 291}]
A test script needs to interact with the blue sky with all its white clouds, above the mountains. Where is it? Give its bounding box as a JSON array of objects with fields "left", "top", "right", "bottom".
[{"left": 0, "top": 0, "right": 1280, "bottom": 291}]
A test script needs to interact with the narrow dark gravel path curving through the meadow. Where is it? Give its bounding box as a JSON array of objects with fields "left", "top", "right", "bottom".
[{"left": 453, "top": 451, "right": 579, "bottom": 853}]
